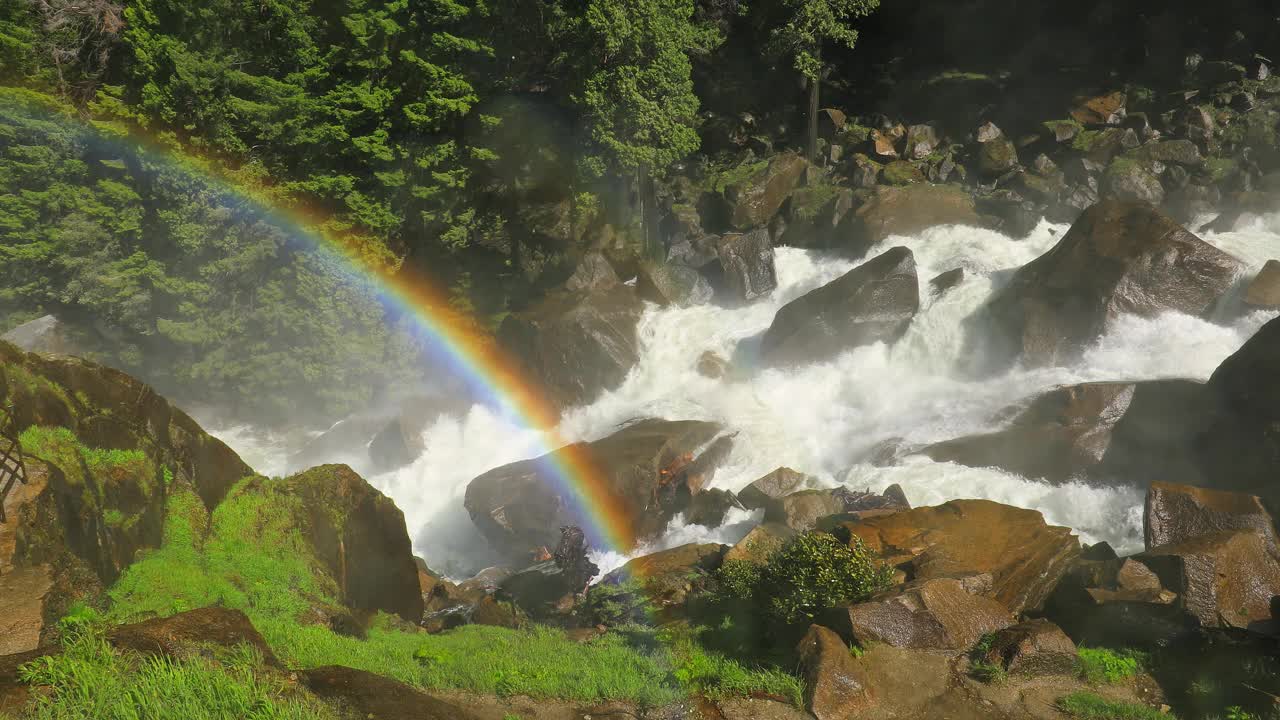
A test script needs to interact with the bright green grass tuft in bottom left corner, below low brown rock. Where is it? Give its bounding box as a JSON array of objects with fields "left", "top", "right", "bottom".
[{"left": 19, "top": 628, "right": 337, "bottom": 720}]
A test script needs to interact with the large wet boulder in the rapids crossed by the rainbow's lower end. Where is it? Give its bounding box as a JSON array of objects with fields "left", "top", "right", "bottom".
[{"left": 463, "top": 419, "right": 721, "bottom": 557}]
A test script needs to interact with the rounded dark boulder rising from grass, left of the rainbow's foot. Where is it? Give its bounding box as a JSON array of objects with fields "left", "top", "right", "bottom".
[{"left": 276, "top": 465, "right": 422, "bottom": 623}]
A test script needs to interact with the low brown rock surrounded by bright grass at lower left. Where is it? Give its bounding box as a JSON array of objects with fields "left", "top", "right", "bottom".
[{"left": 108, "top": 607, "right": 280, "bottom": 666}]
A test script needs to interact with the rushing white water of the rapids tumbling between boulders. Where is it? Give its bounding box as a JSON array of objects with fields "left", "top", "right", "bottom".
[{"left": 212, "top": 208, "right": 1280, "bottom": 575}]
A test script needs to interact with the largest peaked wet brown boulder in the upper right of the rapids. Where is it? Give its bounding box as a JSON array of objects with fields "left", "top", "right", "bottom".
[{"left": 988, "top": 200, "right": 1240, "bottom": 365}]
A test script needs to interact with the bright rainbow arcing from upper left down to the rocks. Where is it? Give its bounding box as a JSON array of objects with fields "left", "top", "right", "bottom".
[{"left": 0, "top": 88, "right": 636, "bottom": 552}]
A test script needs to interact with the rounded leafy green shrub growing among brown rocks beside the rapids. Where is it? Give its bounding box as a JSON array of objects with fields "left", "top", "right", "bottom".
[{"left": 755, "top": 532, "right": 893, "bottom": 623}]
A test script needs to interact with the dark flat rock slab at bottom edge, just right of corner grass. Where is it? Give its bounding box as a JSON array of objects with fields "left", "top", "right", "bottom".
[{"left": 298, "top": 665, "right": 477, "bottom": 720}]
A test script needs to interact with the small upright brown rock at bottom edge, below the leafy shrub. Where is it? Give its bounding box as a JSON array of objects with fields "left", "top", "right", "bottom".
[{"left": 796, "top": 625, "right": 870, "bottom": 720}]
